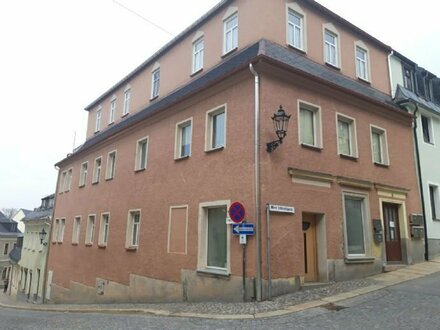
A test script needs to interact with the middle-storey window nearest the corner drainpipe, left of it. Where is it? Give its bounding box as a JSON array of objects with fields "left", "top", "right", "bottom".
[{"left": 205, "top": 105, "right": 226, "bottom": 151}]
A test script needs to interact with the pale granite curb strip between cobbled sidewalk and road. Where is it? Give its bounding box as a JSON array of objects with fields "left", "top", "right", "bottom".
[{"left": 0, "top": 258, "right": 440, "bottom": 320}]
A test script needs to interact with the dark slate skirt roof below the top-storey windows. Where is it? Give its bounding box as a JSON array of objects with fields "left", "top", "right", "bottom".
[{"left": 56, "top": 39, "right": 409, "bottom": 166}]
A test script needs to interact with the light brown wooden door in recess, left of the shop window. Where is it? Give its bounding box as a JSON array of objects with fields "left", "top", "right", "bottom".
[{"left": 302, "top": 214, "right": 318, "bottom": 282}]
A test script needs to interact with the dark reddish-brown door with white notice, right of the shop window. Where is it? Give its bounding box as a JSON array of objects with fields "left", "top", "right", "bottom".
[{"left": 382, "top": 203, "right": 402, "bottom": 261}]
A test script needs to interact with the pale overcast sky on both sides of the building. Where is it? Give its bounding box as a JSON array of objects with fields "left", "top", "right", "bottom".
[{"left": 0, "top": 0, "right": 440, "bottom": 209}]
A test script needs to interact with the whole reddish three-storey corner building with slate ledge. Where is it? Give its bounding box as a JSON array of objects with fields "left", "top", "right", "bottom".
[{"left": 47, "top": 0, "right": 423, "bottom": 302}]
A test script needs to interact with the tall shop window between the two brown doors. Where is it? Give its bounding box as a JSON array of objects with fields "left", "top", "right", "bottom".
[{"left": 343, "top": 192, "right": 370, "bottom": 257}]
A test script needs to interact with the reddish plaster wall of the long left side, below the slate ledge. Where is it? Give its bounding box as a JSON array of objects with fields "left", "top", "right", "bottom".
[{"left": 49, "top": 71, "right": 255, "bottom": 296}]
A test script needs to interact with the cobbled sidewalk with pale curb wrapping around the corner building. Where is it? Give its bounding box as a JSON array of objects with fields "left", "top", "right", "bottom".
[{"left": 0, "top": 258, "right": 440, "bottom": 320}]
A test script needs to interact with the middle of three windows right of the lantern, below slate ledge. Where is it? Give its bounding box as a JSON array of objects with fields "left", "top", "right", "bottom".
[{"left": 336, "top": 113, "right": 358, "bottom": 157}]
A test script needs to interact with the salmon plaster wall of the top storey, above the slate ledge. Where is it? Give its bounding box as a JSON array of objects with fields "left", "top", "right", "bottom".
[{"left": 87, "top": 0, "right": 390, "bottom": 138}]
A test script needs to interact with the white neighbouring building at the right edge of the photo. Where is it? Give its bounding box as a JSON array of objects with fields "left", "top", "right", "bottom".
[{"left": 390, "top": 52, "right": 440, "bottom": 258}]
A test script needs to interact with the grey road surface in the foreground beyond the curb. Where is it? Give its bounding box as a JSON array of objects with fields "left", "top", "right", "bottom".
[{"left": 0, "top": 273, "right": 440, "bottom": 330}]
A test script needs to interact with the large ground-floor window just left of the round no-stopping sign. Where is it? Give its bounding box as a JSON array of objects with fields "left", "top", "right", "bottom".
[{"left": 197, "top": 201, "right": 231, "bottom": 275}]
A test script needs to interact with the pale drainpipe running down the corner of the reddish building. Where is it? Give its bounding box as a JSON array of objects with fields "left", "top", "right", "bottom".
[{"left": 249, "top": 63, "right": 262, "bottom": 301}]
